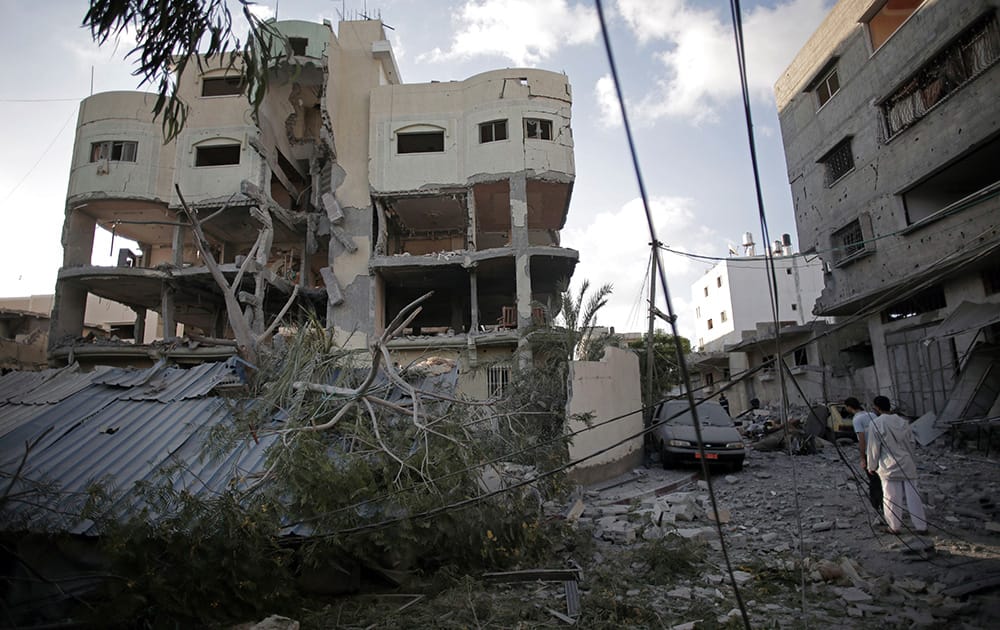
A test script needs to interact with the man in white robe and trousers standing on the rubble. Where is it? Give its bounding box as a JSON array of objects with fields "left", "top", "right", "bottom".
[{"left": 867, "top": 396, "right": 927, "bottom": 534}]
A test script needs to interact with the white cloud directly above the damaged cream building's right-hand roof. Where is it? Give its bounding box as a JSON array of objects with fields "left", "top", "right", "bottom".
[{"left": 417, "top": 0, "right": 598, "bottom": 66}]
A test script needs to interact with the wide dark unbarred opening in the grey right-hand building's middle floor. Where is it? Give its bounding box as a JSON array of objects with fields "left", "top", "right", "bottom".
[{"left": 902, "top": 133, "right": 1000, "bottom": 225}]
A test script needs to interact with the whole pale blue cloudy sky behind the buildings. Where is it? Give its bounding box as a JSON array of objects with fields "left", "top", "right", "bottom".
[{"left": 0, "top": 0, "right": 832, "bottom": 334}]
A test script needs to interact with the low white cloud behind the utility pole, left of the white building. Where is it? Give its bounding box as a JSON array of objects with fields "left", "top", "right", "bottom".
[{"left": 562, "top": 197, "right": 720, "bottom": 344}]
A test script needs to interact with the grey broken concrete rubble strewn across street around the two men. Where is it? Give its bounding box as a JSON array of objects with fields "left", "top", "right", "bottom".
[{"left": 550, "top": 445, "right": 1000, "bottom": 628}]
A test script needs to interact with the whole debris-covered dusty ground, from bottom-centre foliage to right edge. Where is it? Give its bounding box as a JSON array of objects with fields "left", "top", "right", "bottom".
[{"left": 302, "top": 444, "right": 1000, "bottom": 628}]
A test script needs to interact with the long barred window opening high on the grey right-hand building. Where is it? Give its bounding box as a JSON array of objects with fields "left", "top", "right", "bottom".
[{"left": 880, "top": 14, "right": 1000, "bottom": 140}]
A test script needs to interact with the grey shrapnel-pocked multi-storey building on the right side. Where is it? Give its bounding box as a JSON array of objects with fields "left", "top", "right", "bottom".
[{"left": 775, "top": 0, "right": 1000, "bottom": 421}]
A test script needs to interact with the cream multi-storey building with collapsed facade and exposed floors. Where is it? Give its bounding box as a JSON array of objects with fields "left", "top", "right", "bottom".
[{"left": 49, "top": 19, "right": 578, "bottom": 395}]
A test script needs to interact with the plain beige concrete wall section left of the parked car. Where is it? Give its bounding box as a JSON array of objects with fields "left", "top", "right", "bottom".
[{"left": 567, "top": 346, "right": 643, "bottom": 484}]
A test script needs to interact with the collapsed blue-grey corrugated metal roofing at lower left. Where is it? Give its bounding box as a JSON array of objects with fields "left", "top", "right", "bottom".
[{"left": 0, "top": 360, "right": 456, "bottom": 535}]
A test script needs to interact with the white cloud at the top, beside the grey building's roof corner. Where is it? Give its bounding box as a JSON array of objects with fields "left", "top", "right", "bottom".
[{"left": 619, "top": 0, "right": 829, "bottom": 122}]
